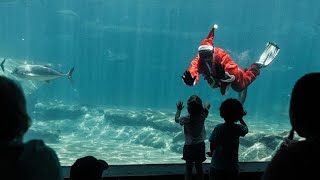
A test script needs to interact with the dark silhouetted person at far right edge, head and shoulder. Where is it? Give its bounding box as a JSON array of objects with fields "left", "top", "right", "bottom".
[{"left": 262, "top": 73, "right": 320, "bottom": 180}]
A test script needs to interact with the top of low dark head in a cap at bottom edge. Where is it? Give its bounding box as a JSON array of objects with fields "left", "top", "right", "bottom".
[{"left": 70, "top": 156, "right": 109, "bottom": 180}]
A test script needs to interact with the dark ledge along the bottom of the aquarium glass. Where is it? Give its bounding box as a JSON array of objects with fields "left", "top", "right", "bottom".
[{"left": 63, "top": 162, "right": 268, "bottom": 180}]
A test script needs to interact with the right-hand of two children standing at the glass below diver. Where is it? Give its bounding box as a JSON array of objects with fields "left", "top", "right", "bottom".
[{"left": 208, "top": 98, "right": 248, "bottom": 180}]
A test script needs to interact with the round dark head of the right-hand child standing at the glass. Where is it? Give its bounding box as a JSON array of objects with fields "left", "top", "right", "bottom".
[{"left": 220, "top": 98, "right": 246, "bottom": 122}]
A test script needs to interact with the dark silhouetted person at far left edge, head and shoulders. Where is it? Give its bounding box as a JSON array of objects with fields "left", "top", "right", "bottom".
[{"left": 0, "top": 76, "right": 63, "bottom": 180}]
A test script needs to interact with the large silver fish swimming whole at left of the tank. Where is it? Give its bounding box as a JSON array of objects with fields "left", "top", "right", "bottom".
[{"left": 11, "top": 64, "right": 74, "bottom": 82}]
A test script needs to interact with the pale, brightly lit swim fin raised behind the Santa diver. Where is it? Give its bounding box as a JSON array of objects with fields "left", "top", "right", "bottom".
[{"left": 256, "top": 42, "right": 280, "bottom": 67}]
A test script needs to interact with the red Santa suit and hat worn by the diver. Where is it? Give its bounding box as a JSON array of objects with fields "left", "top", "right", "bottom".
[{"left": 188, "top": 27, "right": 260, "bottom": 95}]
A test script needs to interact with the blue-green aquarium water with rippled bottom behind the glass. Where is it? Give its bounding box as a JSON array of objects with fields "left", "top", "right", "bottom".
[{"left": 0, "top": 0, "right": 320, "bottom": 165}]
